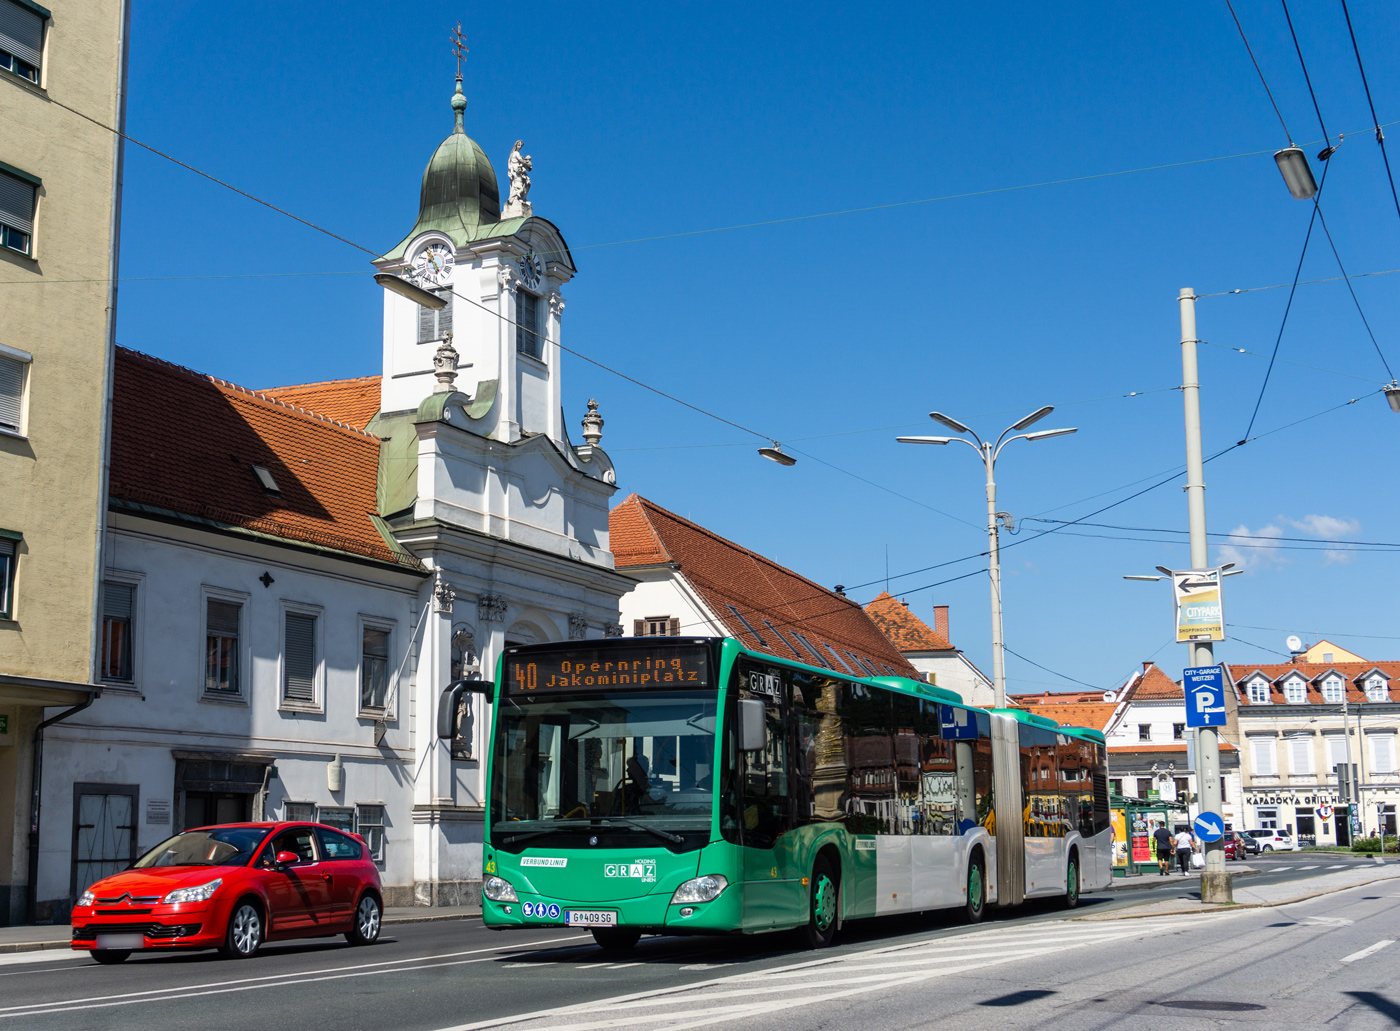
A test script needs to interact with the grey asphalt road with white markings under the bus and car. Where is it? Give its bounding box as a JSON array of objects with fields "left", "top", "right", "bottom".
[{"left": 0, "top": 854, "right": 1400, "bottom": 1031}]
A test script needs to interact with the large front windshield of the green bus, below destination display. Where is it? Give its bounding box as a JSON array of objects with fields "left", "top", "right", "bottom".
[{"left": 491, "top": 689, "right": 718, "bottom": 845}]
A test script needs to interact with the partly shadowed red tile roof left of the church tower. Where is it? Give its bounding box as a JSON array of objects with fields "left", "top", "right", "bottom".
[{"left": 108, "top": 347, "right": 416, "bottom": 565}]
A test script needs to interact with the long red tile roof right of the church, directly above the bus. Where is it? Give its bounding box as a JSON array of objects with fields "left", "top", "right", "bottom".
[{"left": 608, "top": 494, "right": 923, "bottom": 679}]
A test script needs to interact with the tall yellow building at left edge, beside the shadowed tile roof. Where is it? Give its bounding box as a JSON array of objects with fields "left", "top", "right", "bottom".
[{"left": 0, "top": 0, "right": 129, "bottom": 923}]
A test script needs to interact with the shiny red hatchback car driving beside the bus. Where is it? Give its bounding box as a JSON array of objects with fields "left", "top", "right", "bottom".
[{"left": 73, "top": 824, "right": 384, "bottom": 962}]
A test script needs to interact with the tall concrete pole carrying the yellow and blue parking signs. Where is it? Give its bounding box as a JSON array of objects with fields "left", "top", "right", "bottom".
[{"left": 1177, "top": 286, "right": 1235, "bottom": 902}]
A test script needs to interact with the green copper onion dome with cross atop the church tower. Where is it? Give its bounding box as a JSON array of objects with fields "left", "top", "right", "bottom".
[{"left": 385, "top": 76, "right": 501, "bottom": 258}]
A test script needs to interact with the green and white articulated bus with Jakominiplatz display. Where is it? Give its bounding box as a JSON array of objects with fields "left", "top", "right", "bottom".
[{"left": 438, "top": 637, "right": 1113, "bottom": 948}]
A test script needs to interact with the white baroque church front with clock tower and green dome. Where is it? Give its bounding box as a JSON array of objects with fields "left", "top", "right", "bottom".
[{"left": 367, "top": 74, "right": 633, "bottom": 905}]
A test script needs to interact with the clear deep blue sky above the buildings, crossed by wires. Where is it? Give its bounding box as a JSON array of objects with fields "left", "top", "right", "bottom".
[{"left": 118, "top": 0, "right": 1400, "bottom": 691}]
